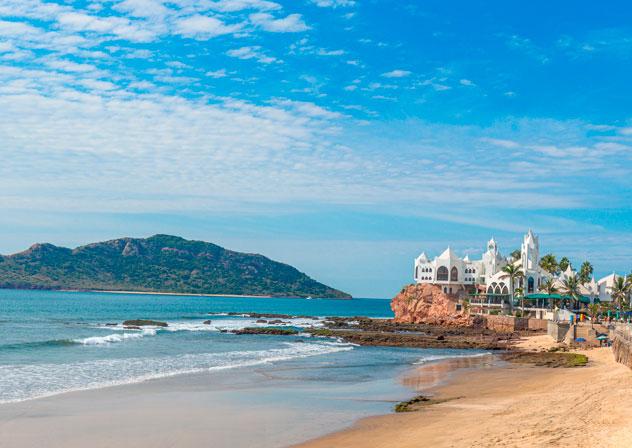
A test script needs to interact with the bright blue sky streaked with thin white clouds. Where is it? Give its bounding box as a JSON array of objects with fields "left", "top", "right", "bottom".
[{"left": 0, "top": 0, "right": 632, "bottom": 298}]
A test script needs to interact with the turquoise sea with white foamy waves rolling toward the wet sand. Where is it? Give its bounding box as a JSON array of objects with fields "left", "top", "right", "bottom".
[{"left": 0, "top": 290, "right": 484, "bottom": 403}]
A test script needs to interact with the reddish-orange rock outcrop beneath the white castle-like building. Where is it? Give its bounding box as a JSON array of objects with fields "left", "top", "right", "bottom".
[{"left": 391, "top": 285, "right": 471, "bottom": 327}]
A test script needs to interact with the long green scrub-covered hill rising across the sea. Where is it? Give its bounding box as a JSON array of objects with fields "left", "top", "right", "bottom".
[{"left": 0, "top": 235, "right": 351, "bottom": 298}]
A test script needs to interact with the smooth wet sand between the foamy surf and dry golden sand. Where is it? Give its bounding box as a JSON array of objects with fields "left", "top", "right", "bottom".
[{"left": 0, "top": 355, "right": 493, "bottom": 448}]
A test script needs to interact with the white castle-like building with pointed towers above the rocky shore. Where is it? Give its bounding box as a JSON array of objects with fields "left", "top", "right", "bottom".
[{"left": 413, "top": 230, "right": 618, "bottom": 316}]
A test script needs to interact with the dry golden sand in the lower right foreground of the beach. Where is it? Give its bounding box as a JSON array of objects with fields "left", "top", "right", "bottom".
[{"left": 298, "top": 336, "right": 632, "bottom": 448}]
